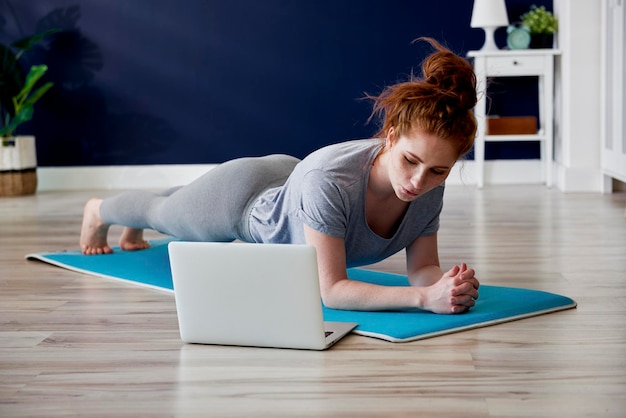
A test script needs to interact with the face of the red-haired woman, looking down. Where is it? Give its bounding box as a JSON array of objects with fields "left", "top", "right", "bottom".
[{"left": 385, "top": 128, "right": 457, "bottom": 202}]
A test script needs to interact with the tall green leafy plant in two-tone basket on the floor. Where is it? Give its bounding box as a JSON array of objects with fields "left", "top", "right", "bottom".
[{"left": 0, "top": 30, "right": 56, "bottom": 196}]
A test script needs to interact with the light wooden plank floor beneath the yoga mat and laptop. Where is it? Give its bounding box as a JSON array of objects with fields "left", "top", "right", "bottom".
[{"left": 0, "top": 186, "right": 626, "bottom": 417}]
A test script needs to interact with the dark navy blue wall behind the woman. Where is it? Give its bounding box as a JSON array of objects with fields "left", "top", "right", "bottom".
[{"left": 0, "top": 0, "right": 551, "bottom": 166}]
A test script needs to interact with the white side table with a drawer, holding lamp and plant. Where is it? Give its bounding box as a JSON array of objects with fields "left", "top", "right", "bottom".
[{"left": 467, "top": 49, "right": 561, "bottom": 188}]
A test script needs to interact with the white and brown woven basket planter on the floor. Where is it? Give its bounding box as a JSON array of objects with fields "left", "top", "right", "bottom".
[{"left": 0, "top": 136, "right": 37, "bottom": 197}]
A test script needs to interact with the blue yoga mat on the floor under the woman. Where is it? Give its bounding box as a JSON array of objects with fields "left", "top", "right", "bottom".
[{"left": 26, "top": 239, "right": 576, "bottom": 342}]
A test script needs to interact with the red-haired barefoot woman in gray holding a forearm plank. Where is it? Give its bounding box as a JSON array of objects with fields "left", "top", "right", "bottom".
[{"left": 80, "top": 38, "right": 479, "bottom": 313}]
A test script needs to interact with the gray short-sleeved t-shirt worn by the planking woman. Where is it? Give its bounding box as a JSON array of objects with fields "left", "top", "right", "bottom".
[{"left": 249, "top": 139, "right": 444, "bottom": 267}]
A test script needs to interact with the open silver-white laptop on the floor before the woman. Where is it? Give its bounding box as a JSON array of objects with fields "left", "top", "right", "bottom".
[{"left": 168, "top": 241, "right": 357, "bottom": 350}]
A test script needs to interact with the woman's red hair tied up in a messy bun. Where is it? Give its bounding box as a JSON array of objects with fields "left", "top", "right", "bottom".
[{"left": 366, "top": 38, "right": 477, "bottom": 158}]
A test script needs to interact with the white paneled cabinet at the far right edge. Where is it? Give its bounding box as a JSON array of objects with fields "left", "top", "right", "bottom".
[{"left": 601, "top": 0, "right": 626, "bottom": 193}]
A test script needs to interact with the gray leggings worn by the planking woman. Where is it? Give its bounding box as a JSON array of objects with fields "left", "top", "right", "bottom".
[{"left": 100, "top": 155, "right": 300, "bottom": 242}]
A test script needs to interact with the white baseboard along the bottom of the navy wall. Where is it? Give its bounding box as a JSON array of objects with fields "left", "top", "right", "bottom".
[{"left": 37, "top": 160, "right": 543, "bottom": 191}]
